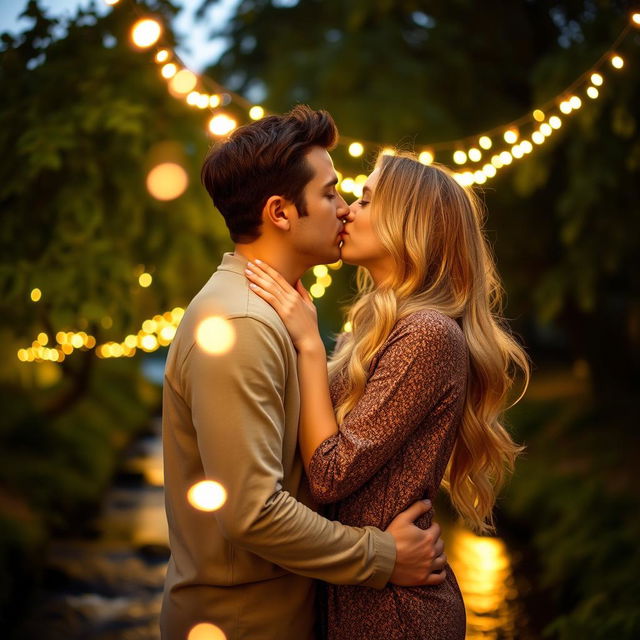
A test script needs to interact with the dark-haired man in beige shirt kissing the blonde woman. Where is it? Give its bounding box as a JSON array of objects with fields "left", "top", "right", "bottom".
[{"left": 161, "top": 106, "right": 445, "bottom": 640}]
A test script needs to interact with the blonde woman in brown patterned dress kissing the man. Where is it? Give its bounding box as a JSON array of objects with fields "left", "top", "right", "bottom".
[{"left": 242, "top": 155, "right": 528, "bottom": 640}]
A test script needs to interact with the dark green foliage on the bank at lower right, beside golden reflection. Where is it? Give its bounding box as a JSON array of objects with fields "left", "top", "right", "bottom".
[{"left": 502, "top": 390, "right": 640, "bottom": 640}]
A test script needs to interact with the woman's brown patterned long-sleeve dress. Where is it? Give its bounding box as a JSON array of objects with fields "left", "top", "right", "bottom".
[{"left": 309, "top": 310, "right": 468, "bottom": 640}]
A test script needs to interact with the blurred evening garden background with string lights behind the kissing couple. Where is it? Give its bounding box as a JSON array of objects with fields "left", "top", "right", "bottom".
[{"left": 0, "top": 0, "right": 640, "bottom": 640}]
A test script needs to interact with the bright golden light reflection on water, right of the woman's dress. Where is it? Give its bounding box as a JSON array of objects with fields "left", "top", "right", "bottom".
[{"left": 446, "top": 525, "right": 517, "bottom": 640}]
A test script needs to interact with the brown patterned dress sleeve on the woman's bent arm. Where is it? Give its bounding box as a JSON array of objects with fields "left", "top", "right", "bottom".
[{"left": 308, "top": 315, "right": 466, "bottom": 503}]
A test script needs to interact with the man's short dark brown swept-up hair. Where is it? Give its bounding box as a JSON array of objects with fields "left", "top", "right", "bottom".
[{"left": 200, "top": 105, "right": 338, "bottom": 242}]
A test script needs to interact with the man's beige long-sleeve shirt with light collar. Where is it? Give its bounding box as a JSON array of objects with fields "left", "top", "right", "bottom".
[{"left": 161, "top": 253, "right": 395, "bottom": 640}]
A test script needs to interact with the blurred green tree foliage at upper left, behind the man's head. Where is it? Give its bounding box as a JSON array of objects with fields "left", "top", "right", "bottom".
[{"left": 0, "top": 0, "right": 226, "bottom": 344}]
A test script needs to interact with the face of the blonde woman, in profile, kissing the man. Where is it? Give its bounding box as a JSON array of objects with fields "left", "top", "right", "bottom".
[{"left": 340, "top": 169, "right": 391, "bottom": 281}]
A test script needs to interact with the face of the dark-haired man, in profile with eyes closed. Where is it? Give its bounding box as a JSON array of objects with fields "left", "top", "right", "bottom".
[{"left": 291, "top": 147, "right": 349, "bottom": 266}]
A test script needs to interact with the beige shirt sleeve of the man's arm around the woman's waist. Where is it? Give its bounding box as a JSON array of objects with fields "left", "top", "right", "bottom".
[{"left": 183, "top": 317, "right": 396, "bottom": 589}]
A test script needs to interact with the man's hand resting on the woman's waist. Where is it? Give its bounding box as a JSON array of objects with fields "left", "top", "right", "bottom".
[{"left": 387, "top": 500, "right": 447, "bottom": 587}]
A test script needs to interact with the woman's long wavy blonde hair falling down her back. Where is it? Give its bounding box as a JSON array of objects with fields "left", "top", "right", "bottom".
[{"left": 329, "top": 153, "right": 529, "bottom": 532}]
